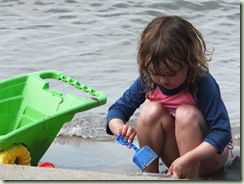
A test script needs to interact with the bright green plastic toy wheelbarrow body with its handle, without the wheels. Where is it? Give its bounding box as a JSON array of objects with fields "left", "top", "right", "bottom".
[{"left": 0, "top": 71, "right": 107, "bottom": 166}]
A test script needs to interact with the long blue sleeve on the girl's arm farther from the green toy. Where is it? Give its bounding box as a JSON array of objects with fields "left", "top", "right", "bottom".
[{"left": 197, "top": 73, "right": 232, "bottom": 153}]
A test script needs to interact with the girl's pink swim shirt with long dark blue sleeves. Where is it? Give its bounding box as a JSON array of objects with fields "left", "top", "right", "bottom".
[{"left": 106, "top": 73, "right": 232, "bottom": 153}]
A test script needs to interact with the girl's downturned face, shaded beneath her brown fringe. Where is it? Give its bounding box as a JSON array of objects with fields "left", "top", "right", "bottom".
[{"left": 149, "top": 63, "right": 186, "bottom": 89}]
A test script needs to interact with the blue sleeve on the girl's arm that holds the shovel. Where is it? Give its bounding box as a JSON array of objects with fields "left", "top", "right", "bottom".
[{"left": 106, "top": 77, "right": 146, "bottom": 135}]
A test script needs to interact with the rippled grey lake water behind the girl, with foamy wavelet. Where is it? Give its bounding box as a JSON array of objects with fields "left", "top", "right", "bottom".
[{"left": 0, "top": 0, "right": 240, "bottom": 177}]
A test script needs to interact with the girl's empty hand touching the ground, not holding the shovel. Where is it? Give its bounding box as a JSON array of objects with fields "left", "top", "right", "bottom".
[{"left": 167, "top": 155, "right": 200, "bottom": 179}]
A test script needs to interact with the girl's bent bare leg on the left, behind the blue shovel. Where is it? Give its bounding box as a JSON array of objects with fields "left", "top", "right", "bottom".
[{"left": 137, "top": 102, "right": 179, "bottom": 173}]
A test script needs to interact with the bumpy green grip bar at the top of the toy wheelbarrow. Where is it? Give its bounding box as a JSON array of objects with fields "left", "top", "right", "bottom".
[{"left": 37, "top": 70, "right": 107, "bottom": 105}]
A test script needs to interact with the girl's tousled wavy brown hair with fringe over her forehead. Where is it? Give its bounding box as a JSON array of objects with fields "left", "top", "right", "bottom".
[{"left": 137, "top": 16, "right": 212, "bottom": 98}]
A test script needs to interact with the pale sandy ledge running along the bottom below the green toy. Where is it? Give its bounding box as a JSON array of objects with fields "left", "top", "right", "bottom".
[{"left": 0, "top": 164, "right": 174, "bottom": 180}]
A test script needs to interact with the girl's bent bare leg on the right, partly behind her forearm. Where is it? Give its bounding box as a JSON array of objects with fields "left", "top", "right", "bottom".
[{"left": 175, "top": 104, "right": 228, "bottom": 176}]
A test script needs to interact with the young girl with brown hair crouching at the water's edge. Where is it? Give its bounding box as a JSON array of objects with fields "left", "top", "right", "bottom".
[{"left": 107, "top": 16, "right": 231, "bottom": 179}]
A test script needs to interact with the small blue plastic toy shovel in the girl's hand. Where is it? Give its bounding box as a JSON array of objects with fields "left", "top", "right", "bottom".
[{"left": 116, "top": 134, "right": 158, "bottom": 172}]
